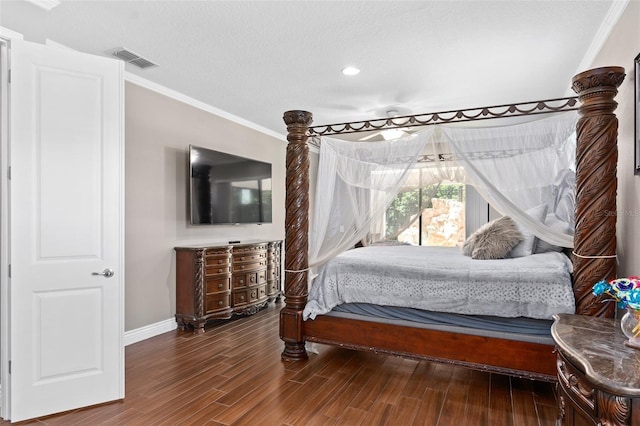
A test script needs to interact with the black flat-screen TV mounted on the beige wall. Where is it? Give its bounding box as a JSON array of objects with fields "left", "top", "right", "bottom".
[{"left": 189, "top": 145, "right": 272, "bottom": 225}]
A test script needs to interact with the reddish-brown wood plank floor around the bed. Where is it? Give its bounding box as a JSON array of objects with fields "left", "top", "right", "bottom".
[{"left": 10, "top": 304, "right": 556, "bottom": 426}]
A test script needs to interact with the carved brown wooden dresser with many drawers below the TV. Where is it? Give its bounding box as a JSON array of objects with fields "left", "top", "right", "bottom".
[{"left": 175, "top": 240, "right": 282, "bottom": 333}]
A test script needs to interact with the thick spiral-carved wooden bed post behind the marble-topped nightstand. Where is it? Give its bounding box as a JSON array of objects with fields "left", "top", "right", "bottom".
[{"left": 572, "top": 67, "right": 625, "bottom": 317}]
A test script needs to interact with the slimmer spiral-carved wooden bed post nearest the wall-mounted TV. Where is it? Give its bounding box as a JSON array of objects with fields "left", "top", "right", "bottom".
[{"left": 280, "top": 111, "right": 313, "bottom": 361}]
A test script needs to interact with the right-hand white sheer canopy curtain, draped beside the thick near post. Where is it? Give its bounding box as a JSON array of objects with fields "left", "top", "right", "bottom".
[{"left": 441, "top": 111, "right": 578, "bottom": 247}]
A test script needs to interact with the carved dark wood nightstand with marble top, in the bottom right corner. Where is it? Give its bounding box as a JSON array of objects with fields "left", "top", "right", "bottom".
[{"left": 551, "top": 314, "right": 640, "bottom": 426}]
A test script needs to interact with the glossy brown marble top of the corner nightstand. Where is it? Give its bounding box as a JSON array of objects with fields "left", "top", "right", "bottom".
[{"left": 551, "top": 314, "right": 640, "bottom": 397}]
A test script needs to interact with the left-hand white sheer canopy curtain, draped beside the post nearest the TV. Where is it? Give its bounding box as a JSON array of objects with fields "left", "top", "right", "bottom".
[{"left": 309, "top": 128, "right": 434, "bottom": 267}]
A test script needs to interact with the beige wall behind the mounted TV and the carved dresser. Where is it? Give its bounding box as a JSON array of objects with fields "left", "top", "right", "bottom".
[{"left": 125, "top": 83, "right": 286, "bottom": 331}]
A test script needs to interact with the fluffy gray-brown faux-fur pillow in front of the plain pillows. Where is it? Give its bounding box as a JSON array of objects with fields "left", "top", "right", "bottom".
[{"left": 462, "top": 216, "right": 522, "bottom": 259}]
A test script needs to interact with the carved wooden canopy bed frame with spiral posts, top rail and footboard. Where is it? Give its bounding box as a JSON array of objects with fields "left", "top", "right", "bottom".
[{"left": 280, "top": 67, "right": 625, "bottom": 381}]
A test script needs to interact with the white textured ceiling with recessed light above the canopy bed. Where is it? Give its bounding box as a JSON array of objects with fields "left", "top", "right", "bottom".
[{"left": 0, "top": 0, "right": 626, "bottom": 135}]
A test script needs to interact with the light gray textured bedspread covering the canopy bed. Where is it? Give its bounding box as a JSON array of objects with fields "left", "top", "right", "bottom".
[{"left": 304, "top": 246, "right": 575, "bottom": 320}]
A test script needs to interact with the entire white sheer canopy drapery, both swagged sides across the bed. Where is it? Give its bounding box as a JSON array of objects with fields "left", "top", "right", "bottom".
[{"left": 309, "top": 112, "right": 578, "bottom": 267}]
